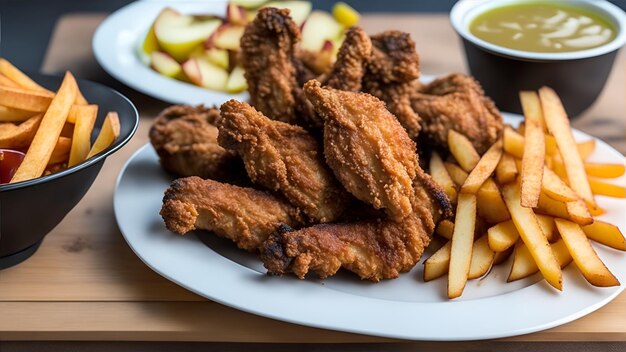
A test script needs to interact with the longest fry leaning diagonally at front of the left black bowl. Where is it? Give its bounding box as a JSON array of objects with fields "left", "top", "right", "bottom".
[{"left": 11, "top": 72, "right": 78, "bottom": 183}]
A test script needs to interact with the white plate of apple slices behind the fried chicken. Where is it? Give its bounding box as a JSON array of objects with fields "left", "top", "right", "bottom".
[{"left": 93, "top": 0, "right": 343, "bottom": 105}]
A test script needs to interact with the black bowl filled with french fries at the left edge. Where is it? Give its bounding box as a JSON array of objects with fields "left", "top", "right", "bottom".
[{"left": 0, "top": 65, "right": 139, "bottom": 269}]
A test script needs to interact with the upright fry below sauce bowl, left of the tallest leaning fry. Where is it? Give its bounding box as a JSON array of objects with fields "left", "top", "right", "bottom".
[{"left": 520, "top": 91, "right": 546, "bottom": 208}]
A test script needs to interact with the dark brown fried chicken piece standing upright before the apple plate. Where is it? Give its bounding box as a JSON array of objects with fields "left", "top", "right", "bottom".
[{"left": 240, "top": 7, "right": 300, "bottom": 122}]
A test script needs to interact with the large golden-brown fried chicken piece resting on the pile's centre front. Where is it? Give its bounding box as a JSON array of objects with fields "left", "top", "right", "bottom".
[{"left": 304, "top": 80, "right": 419, "bottom": 221}]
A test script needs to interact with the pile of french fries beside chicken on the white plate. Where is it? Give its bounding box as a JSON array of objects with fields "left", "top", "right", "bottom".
[{"left": 424, "top": 87, "right": 626, "bottom": 298}]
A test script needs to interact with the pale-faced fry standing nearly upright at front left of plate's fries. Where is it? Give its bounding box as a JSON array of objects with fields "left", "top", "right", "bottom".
[{"left": 448, "top": 194, "right": 476, "bottom": 298}]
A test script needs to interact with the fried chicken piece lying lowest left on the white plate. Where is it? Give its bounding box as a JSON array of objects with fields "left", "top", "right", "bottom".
[{"left": 160, "top": 177, "right": 302, "bottom": 251}]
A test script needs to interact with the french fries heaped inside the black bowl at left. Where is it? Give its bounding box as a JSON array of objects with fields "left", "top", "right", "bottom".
[{"left": 0, "top": 58, "right": 120, "bottom": 183}]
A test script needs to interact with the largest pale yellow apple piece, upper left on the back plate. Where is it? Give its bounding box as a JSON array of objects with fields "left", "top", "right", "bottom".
[{"left": 154, "top": 8, "right": 222, "bottom": 62}]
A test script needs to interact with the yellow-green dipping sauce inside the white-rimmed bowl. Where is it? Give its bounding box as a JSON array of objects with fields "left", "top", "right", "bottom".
[{"left": 469, "top": 1, "right": 617, "bottom": 53}]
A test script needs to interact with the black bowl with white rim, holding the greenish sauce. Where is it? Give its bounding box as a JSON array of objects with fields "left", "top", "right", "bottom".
[{"left": 450, "top": 0, "right": 626, "bottom": 117}]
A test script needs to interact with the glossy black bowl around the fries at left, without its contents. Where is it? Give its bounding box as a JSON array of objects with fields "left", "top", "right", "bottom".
[{"left": 0, "top": 73, "right": 139, "bottom": 269}]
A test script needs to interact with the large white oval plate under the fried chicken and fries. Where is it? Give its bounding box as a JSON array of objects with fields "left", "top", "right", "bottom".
[{"left": 114, "top": 114, "right": 626, "bottom": 340}]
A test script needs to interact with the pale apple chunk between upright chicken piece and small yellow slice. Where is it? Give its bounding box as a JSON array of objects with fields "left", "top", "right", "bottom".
[{"left": 300, "top": 11, "right": 343, "bottom": 53}]
